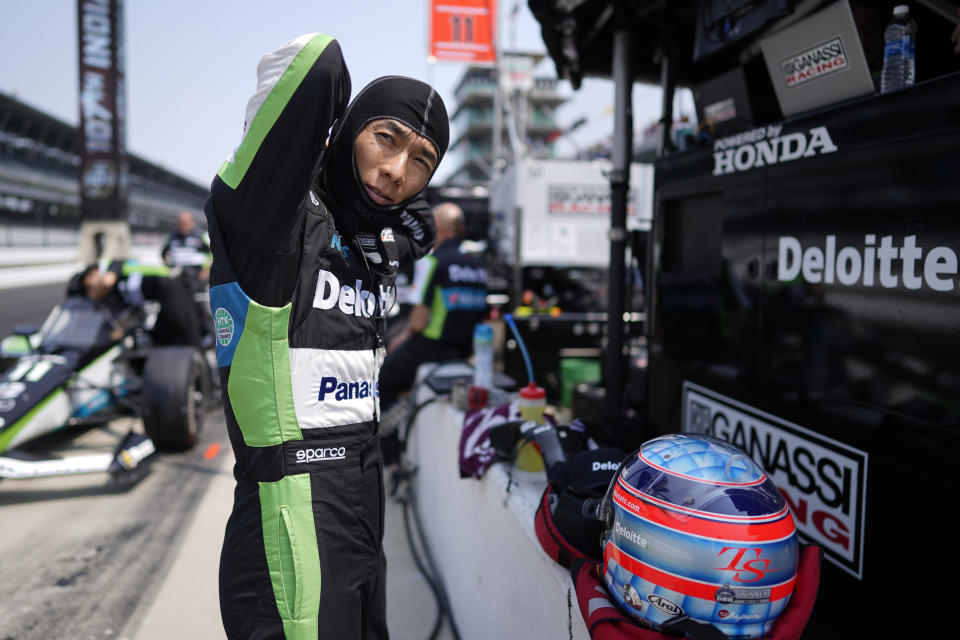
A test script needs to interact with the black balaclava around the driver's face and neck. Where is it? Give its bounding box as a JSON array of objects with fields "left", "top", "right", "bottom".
[{"left": 321, "top": 76, "right": 450, "bottom": 226}]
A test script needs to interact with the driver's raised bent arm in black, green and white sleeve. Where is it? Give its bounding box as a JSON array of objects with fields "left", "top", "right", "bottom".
[{"left": 205, "top": 34, "right": 350, "bottom": 303}]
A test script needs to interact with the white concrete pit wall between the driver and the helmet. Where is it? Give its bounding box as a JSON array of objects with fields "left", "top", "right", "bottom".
[{"left": 408, "top": 392, "right": 590, "bottom": 640}]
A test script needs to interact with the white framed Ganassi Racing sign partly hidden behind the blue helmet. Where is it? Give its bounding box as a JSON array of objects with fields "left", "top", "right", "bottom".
[{"left": 682, "top": 382, "right": 867, "bottom": 579}]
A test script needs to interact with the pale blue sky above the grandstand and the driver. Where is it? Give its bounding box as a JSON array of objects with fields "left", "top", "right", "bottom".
[{"left": 0, "top": 0, "right": 676, "bottom": 184}]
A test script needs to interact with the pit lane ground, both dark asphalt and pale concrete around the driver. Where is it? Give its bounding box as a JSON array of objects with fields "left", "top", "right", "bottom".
[{"left": 0, "top": 247, "right": 452, "bottom": 640}]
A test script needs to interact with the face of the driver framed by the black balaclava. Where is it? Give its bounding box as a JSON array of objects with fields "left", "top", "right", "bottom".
[{"left": 354, "top": 118, "right": 437, "bottom": 206}]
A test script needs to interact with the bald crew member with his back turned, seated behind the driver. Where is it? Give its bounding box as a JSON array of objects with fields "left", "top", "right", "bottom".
[{"left": 380, "top": 202, "right": 487, "bottom": 408}]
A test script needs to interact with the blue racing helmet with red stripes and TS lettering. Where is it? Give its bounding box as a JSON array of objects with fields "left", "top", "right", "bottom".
[{"left": 598, "top": 434, "right": 798, "bottom": 638}]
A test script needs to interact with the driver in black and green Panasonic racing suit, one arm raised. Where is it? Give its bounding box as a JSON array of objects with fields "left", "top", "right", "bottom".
[{"left": 205, "top": 35, "right": 449, "bottom": 640}]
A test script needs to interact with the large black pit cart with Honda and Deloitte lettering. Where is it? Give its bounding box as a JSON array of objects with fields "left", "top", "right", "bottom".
[{"left": 530, "top": 0, "right": 960, "bottom": 638}]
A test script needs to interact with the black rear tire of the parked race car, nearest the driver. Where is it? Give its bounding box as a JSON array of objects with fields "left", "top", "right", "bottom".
[{"left": 142, "top": 347, "right": 207, "bottom": 451}]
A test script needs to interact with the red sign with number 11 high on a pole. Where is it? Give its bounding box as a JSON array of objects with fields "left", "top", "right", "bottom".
[{"left": 430, "top": 0, "right": 497, "bottom": 64}]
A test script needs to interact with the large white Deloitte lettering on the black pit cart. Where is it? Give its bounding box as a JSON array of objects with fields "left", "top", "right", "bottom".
[{"left": 777, "top": 233, "right": 957, "bottom": 291}]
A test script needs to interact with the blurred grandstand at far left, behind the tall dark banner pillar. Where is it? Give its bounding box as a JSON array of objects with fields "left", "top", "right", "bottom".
[{"left": 0, "top": 92, "right": 209, "bottom": 246}]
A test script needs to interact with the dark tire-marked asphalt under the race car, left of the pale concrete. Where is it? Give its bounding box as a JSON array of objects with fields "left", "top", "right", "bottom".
[{"left": 0, "top": 278, "right": 229, "bottom": 640}]
